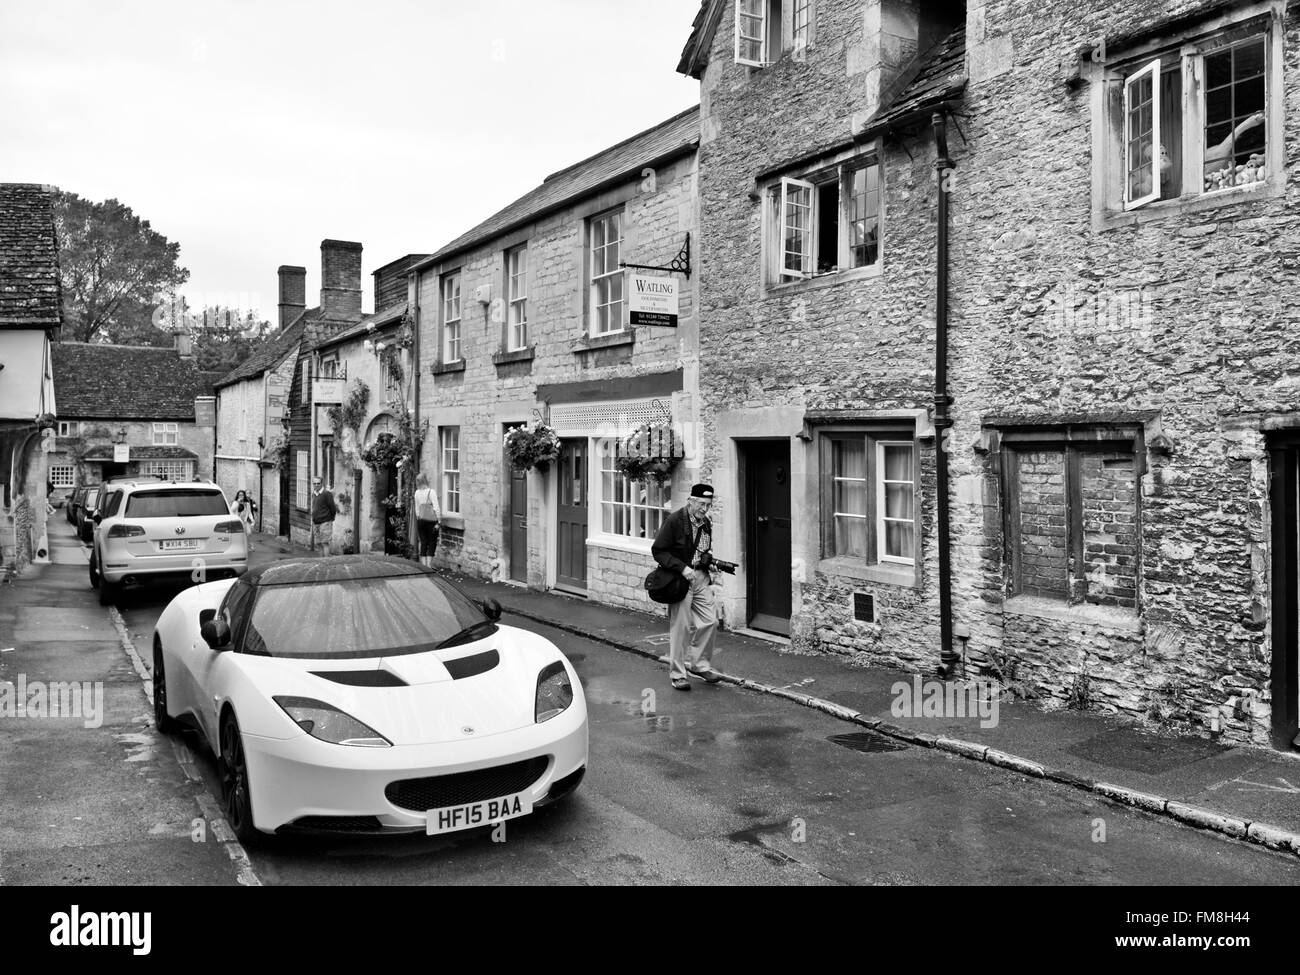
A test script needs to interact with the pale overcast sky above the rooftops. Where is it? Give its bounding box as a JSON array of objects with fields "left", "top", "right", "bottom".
[{"left": 0, "top": 0, "right": 699, "bottom": 320}]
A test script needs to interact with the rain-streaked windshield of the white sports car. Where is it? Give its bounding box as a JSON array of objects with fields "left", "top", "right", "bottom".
[{"left": 243, "top": 575, "right": 497, "bottom": 659}]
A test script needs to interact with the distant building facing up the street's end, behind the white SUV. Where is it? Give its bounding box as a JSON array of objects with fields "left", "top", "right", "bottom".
[{"left": 48, "top": 334, "right": 216, "bottom": 497}]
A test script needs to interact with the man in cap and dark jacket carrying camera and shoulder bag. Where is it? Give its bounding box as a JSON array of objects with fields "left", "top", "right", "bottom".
[{"left": 650, "top": 484, "right": 722, "bottom": 690}]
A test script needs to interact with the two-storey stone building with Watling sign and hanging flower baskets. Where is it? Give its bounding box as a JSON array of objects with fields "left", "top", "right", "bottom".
[{"left": 413, "top": 109, "right": 699, "bottom": 608}]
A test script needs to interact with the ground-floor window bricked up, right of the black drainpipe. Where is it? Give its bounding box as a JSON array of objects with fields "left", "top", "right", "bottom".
[{"left": 1005, "top": 442, "right": 1139, "bottom": 608}]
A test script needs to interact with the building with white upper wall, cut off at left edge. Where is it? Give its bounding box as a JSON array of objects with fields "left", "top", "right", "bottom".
[{"left": 0, "top": 183, "right": 64, "bottom": 572}]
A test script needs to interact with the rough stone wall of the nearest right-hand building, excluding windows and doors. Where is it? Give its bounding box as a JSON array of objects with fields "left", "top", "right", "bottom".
[{"left": 699, "top": 0, "right": 1300, "bottom": 744}]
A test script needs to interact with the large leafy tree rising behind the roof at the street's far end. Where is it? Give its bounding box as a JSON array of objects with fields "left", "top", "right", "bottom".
[{"left": 55, "top": 192, "right": 190, "bottom": 346}]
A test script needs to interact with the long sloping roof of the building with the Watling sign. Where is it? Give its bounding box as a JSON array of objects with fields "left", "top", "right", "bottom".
[{"left": 412, "top": 105, "right": 699, "bottom": 270}]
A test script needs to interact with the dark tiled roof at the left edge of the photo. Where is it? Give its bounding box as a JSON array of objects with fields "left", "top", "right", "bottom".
[{"left": 0, "top": 183, "right": 64, "bottom": 329}]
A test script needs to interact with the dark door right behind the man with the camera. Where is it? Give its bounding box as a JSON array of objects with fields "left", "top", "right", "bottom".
[{"left": 743, "top": 441, "right": 790, "bottom": 636}]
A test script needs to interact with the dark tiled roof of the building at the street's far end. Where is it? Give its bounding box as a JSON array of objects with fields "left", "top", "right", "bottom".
[{"left": 51, "top": 342, "right": 209, "bottom": 423}]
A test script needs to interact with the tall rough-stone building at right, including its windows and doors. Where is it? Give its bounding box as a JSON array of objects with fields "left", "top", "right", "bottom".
[{"left": 679, "top": 0, "right": 1300, "bottom": 746}]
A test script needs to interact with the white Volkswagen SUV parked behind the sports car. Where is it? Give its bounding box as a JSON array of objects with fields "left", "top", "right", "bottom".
[{"left": 90, "top": 478, "right": 248, "bottom": 606}]
